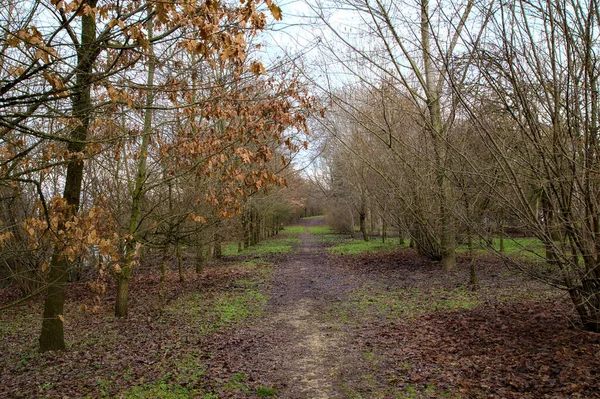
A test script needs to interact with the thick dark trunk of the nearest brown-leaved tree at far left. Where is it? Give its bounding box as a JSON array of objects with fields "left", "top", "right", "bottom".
[{"left": 39, "top": 0, "right": 99, "bottom": 352}]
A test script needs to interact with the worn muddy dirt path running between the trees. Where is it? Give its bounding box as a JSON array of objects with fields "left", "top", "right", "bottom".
[{"left": 210, "top": 219, "right": 351, "bottom": 399}]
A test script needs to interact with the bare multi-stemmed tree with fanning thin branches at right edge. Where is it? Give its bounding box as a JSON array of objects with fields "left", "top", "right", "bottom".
[{"left": 455, "top": 0, "right": 600, "bottom": 331}]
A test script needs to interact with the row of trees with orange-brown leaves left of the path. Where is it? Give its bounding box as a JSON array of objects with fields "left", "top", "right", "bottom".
[{"left": 0, "top": 0, "right": 312, "bottom": 351}]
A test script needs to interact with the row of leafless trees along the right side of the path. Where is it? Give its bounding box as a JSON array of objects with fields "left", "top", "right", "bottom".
[{"left": 312, "top": 0, "right": 600, "bottom": 331}]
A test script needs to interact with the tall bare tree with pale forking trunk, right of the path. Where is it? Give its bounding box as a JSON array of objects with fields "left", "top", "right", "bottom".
[{"left": 313, "top": 0, "right": 486, "bottom": 269}]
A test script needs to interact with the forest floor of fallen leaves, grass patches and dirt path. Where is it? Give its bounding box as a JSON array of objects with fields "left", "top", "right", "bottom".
[{"left": 0, "top": 219, "right": 600, "bottom": 399}]
